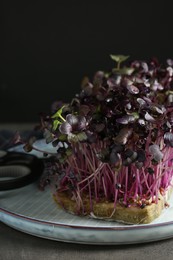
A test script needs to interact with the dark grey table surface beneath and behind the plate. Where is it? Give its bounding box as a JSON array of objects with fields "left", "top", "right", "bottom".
[{"left": 0, "top": 124, "right": 173, "bottom": 260}]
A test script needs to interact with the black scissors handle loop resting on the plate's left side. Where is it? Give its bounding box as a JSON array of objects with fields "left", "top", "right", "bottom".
[{"left": 0, "top": 151, "right": 44, "bottom": 191}]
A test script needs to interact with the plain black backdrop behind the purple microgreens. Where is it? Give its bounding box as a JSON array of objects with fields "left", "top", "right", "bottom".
[{"left": 0, "top": 0, "right": 173, "bottom": 123}]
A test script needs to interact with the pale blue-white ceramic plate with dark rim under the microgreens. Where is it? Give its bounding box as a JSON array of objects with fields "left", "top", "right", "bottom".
[{"left": 0, "top": 141, "right": 173, "bottom": 245}]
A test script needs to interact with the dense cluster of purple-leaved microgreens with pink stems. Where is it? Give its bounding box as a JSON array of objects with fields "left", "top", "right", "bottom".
[{"left": 38, "top": 55, "right": 173, "bottom": 212}]
